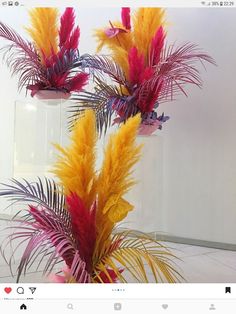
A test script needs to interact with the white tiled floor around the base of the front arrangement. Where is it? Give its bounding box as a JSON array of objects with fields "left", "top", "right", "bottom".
[{"left": 0, "top": 221, "right": 236, "bottom": 283}]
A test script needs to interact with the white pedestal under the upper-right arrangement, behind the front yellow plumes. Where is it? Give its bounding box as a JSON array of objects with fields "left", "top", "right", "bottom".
[{"left": 123, "top": 134, "right": 163, "bottom": 233}]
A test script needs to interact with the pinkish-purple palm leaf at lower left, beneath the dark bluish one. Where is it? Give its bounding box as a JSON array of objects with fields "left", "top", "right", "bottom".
[{"left": 1, "top": 206, "right": 76, "bottom": 282}]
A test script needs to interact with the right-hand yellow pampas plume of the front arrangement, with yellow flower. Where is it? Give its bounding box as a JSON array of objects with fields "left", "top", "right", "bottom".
[{"left": 94, "top": 114, "right": 142, "bottom": 263}]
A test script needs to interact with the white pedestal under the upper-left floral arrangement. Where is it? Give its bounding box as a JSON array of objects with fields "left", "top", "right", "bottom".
[{"left": 13, "top": 99, "right": 68, "bottom": 179}]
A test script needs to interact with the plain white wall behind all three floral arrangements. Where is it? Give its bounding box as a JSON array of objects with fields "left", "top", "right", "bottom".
[{"left": 0, "top": 8, "right": 236, "bottom": 243}]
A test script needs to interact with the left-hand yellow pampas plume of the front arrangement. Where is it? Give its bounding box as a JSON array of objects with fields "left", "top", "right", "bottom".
[{"left": 53, "top": 110, "right": 97, "bottom": 208}]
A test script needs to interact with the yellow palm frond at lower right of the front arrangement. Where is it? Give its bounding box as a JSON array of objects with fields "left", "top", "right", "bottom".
[{"left": 94, "top": 230, "right": 182, "bottom": 283}]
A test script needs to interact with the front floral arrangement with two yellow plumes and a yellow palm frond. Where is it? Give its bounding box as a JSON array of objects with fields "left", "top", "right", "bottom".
[{"left": 0, "top": 110, "right": 179, "bottom": 283}]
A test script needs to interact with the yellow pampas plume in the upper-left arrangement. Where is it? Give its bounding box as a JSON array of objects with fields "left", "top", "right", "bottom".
[{"left": 26, "top": 8, "right": 59, "bottom": 57}]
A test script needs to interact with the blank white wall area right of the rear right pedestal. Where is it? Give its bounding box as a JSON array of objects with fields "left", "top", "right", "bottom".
[{"left": 162, "top": 9, "right": 236, "bottom": 243}]
